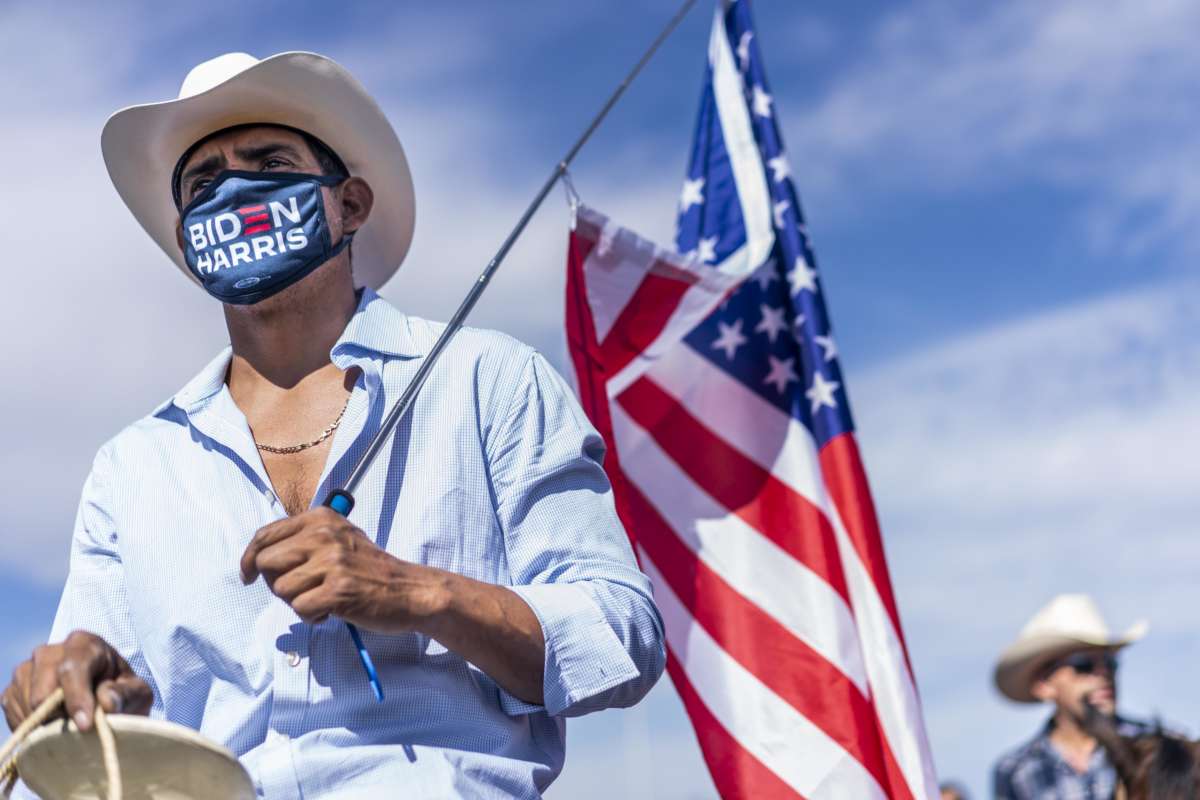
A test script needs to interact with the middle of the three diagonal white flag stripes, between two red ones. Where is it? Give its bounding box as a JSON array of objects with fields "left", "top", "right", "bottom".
[{"left": 612, "top": 403, "right": 870, "bottom": 696}]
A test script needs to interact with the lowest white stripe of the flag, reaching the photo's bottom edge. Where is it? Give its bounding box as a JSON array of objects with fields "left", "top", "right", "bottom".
[{"left": 640, "top": 548, "right": 886, "bottom": 800}]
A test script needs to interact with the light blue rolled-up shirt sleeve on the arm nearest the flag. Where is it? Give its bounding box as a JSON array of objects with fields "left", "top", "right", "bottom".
[{"left": 488, "top": 353, "right": 666, "bottom": 716}]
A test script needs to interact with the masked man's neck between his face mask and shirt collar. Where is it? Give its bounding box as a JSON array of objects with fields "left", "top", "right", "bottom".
[{"left": 226, "top": 275, "right": 358, "bottom": 396}]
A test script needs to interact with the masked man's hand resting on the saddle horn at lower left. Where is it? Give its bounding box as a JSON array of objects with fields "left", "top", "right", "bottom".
[{"left": 0, "top": 631, "right": 154, "bottom": 730}]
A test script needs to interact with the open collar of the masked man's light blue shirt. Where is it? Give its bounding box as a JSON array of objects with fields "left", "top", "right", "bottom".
[{"left": 173, "top": 287, "right": 425, "bottom": 411}]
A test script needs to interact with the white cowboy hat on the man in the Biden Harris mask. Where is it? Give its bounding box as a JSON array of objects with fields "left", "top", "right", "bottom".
[{"left": 100, "top": 53, "right": 415, "bottom": 289}]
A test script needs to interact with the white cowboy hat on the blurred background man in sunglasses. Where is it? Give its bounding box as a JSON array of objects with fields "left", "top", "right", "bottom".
[{"left": 996, "top": 595, "right": 1150, "bottom": 703}]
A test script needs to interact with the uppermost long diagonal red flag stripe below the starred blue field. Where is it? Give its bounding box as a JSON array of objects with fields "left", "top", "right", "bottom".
[{"left": 617, "top": 377, "right": 850, "bottom": 606}]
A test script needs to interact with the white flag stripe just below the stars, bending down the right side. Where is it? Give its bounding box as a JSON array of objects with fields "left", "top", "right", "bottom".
[{"left": 638, "top": 344, "right": 937, "bottom": 798}]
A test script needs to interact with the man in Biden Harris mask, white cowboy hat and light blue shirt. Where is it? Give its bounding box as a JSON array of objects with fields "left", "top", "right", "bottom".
[{"left": 2, "top": 53, "right": 665, "bottom": 799}]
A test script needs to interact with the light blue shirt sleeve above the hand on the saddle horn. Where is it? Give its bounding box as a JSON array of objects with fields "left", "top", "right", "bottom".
[{"left": 49, "top": 447, "right": 160, "bottom": 712}]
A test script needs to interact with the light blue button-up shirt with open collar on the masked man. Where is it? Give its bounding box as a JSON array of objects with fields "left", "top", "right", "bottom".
[{"left": 30, "top": 289, "right": 665, "bottom": 800}]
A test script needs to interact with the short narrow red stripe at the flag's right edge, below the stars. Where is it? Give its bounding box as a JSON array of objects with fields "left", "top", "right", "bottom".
[{"left": 820, "top": 433, "right": 912, "bottom": 674}]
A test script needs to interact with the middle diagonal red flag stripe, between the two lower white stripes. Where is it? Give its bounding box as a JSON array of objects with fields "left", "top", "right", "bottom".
[{"left": 626, "top": 481, "right": 887, "bottom": 786}]
